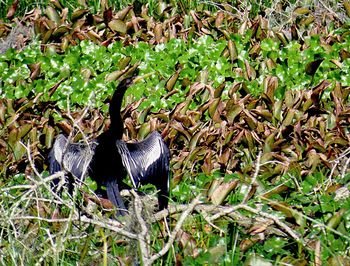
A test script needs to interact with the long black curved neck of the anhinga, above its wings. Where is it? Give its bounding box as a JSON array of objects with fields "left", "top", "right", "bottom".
[{"left": 109, "top": 77, "right": 134, "bottom": 139}]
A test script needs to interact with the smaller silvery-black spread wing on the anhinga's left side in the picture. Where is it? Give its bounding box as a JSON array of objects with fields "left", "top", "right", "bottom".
[{"left": 49, "top": 134, "right": 96, "bottom": 179}]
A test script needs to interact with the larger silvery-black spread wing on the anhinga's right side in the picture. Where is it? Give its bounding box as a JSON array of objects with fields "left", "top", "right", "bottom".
[{"left": 116, "top": 132, "right": 170, "bottom": 191}]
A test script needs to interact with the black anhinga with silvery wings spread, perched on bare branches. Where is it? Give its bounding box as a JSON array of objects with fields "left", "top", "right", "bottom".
[{"left": 49, "top": 71, "right": 170, "bottom": 215}]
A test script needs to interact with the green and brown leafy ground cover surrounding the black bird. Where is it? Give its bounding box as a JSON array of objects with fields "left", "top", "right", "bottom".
[{"left": 0, "top": 1, "right": 350, "bottom": 265}]
